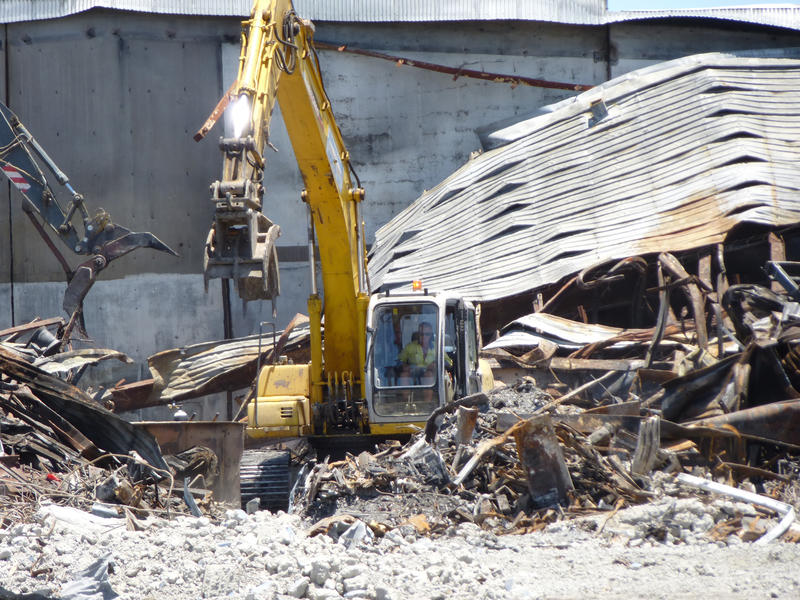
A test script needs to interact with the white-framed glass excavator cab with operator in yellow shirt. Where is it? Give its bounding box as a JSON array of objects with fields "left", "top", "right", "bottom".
[{"left": 366, "top": 293, "right": 482, "bottom": 433}]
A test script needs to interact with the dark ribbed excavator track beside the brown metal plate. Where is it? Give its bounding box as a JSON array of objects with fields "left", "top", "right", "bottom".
[{"left": 239, "top": 450, "right": 291, "bottom": 512}]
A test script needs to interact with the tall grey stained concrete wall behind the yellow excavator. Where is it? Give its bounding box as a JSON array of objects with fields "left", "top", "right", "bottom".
[{"left": 0, "top": 10, "right": 800, "bottom": 418}]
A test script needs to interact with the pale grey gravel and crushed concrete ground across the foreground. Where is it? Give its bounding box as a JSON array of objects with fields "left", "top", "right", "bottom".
[{"left": 0, "top": 498, "right": 800, "bottom": 600}]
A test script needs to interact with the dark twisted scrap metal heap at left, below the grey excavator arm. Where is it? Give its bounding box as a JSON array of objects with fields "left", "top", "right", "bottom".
[{"left": 0, "top": 319, "right": 223, "bottom": 528}]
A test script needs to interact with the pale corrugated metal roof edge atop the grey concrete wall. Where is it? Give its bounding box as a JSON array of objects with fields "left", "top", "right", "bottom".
[{"left": 0, "top": 0, "right": 800, "bottom": 29}]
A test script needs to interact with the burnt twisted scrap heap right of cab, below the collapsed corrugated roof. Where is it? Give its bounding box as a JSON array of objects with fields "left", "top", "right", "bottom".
[{"left": 295, "top": 254, "right": 800, "bottom": 541}]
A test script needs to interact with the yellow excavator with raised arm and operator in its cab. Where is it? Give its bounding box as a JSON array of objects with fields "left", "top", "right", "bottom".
[{"left": 201, "top": 0, "right": 491, "bottom": 496}]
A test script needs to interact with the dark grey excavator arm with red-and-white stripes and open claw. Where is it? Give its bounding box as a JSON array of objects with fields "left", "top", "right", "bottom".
[{"left": 0, "top": 103, "right": 177, "bottom": 330}]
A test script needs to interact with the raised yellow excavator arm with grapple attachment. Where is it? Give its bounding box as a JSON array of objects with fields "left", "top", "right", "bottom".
[{"left": 203, "top": 0, "right": 369, "bottom": 401}]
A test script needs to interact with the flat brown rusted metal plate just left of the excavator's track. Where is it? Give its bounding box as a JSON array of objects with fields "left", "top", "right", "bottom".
[{"left": 134, "top": 421, "right": 244, "bottom": 508}]
